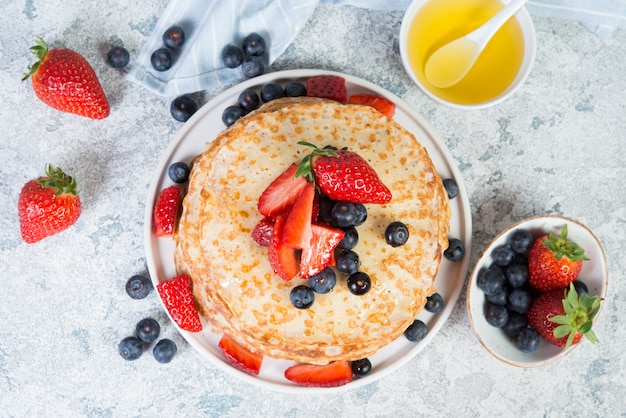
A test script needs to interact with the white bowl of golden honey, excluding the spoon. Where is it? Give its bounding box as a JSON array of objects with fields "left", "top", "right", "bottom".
[{"left": 400, "top": 0, "right": 537, "bottom": 109}]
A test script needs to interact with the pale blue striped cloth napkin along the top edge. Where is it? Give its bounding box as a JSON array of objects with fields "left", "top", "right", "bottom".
[{"left": 128, "top": 0, "right": 626, "bottom": 96}]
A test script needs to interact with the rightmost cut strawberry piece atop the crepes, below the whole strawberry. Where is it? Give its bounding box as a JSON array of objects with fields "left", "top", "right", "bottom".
[{"left": 300, "top": 224, "right": 346, "bottom": 279}]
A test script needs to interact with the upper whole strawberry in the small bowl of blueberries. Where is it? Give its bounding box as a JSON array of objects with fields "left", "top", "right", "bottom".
[{"left": 528, "top": 225, "right": 589, "bottom": 292}]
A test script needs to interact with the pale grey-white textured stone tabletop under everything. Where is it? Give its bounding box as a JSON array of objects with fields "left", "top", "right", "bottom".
[{"left": 0, "top": 0, "right": 626, "bottom": 417}]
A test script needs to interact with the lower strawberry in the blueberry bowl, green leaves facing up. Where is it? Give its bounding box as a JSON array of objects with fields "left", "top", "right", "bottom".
[{"left": 526, "top": 284, "right": 601, "bottom": 348}]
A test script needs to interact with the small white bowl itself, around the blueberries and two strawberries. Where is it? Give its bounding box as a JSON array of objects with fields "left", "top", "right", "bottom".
[{"left": 467, "top": 216, "right": 608, "bottom": 367}]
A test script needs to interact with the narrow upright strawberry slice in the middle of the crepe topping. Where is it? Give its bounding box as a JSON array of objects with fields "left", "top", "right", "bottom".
[{"left": 283, "top": 183, "right": 315, "bottom": 249}]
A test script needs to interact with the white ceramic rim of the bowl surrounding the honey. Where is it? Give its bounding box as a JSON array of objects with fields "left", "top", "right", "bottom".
[{"left": 400, "top": 0, "right": 537, "bottom": 110}]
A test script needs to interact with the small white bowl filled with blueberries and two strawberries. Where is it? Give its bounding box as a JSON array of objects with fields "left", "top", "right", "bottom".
[{"left": 467, "top": 215, "right": 608, "bottom": 367}]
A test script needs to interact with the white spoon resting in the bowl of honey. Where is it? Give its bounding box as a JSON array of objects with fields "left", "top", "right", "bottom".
[{"left": 424, "top": 0, "right": 528, "bottom": 88}]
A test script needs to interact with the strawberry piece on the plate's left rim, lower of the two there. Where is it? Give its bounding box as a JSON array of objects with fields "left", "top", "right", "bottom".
[{"left": 157, "top": 274, "right": 202, "bottom": 332}]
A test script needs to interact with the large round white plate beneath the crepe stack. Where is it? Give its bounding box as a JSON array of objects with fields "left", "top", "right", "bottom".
[{"left": 144, "top": 70, "right": 472, "bottom": 393}]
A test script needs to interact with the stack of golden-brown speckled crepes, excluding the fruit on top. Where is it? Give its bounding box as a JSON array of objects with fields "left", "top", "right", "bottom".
[{"left": 174, "top": 97, "right": 450, "bottom": 364}]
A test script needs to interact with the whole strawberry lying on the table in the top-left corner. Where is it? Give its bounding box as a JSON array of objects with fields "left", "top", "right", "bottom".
[{"left": 22, "top": 37, "right": 110, "bottom": 119}]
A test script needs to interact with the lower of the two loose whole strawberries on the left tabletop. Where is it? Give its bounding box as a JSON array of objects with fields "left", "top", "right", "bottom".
[{"left": 17, "top": 165, "right": 81, "bottom": 244}]
